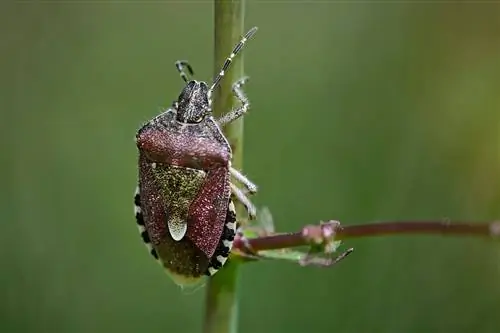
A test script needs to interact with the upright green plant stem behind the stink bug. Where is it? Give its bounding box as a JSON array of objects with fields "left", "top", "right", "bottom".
[{"left": 203, "top": 0, "right": 245, "bottom": 333}]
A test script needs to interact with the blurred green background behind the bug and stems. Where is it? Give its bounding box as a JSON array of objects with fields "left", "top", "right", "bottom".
[{"left": 0, "top": 1, "right": 500, "bottom": 333}]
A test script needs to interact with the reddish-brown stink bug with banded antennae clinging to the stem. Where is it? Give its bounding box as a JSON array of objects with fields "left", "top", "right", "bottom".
[{"left": 134, "top": 27, "right": 257, "bottom": 286}]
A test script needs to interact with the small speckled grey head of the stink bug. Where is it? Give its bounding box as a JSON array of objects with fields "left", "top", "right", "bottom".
[{"left": 177, "top": 80, "right": 211, "bottom": 124}]
